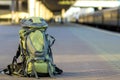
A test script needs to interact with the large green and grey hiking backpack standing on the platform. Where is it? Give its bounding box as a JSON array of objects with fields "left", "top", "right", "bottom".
[{"left": 1, "top": 17, "right": 63, "bottom": 78}]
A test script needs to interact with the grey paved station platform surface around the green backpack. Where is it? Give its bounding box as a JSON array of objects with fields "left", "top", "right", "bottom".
[{"left": 0, "top": 23, "right": 120, "bottom": 80}]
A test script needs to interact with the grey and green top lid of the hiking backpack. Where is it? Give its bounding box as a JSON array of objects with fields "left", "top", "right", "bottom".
[{"left": 20, "top": 17, "right": 48, "bottom": 29}]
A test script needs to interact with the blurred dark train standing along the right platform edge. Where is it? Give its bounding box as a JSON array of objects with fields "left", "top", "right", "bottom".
[{"left": 78, "top": 7, "right": 120, "bottom": 31}]
